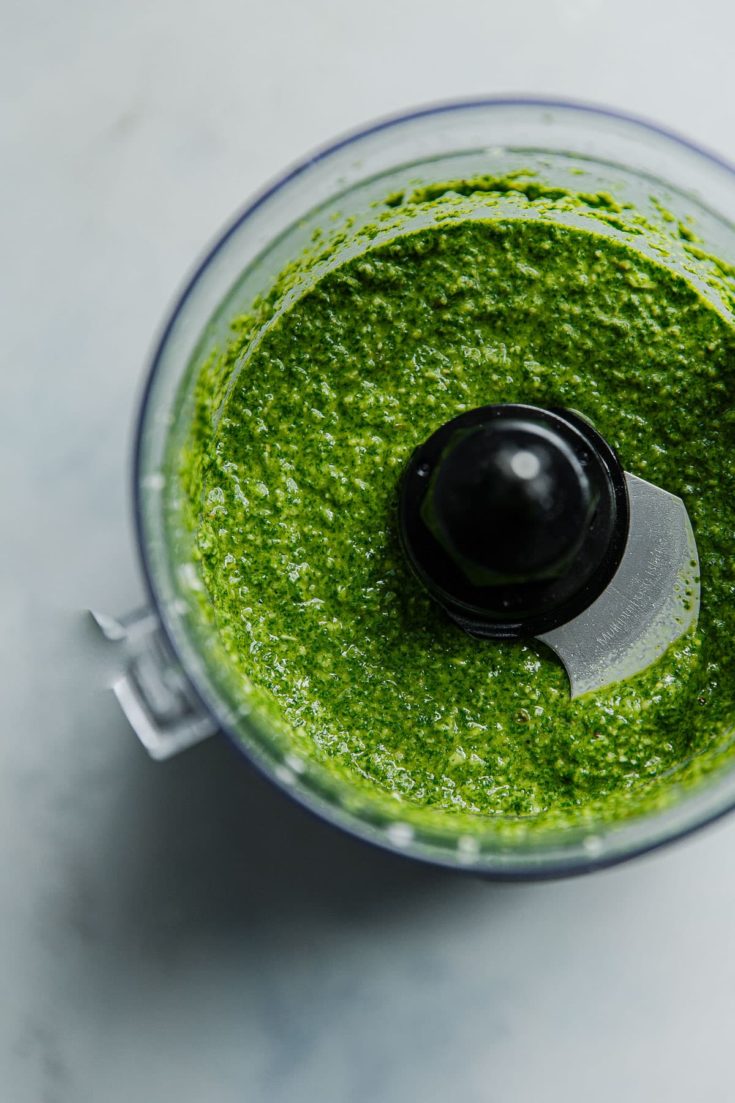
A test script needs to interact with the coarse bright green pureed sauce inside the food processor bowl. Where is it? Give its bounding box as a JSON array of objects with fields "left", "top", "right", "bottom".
[{"left": 177, "top": 181, "right": 735, "bottom": 831}]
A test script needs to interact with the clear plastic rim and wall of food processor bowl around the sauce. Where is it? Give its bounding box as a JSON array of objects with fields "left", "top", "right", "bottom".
[{"left": 135, "top": 99, "right": 735, "bottom": 878}]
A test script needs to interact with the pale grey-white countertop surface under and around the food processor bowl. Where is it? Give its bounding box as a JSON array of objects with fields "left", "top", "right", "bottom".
[{"left": 0, "top": 0, "right": 735, "bottom": 1103}]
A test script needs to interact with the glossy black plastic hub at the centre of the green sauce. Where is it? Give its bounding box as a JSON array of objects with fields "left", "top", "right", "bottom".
[{"left": 400, "top": 405, "right": 629, "bottom": 639}]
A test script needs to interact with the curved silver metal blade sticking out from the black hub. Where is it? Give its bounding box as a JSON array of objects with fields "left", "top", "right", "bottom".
[{"left": 537, "top": 472, "right": 700, "bottom": 697}]
